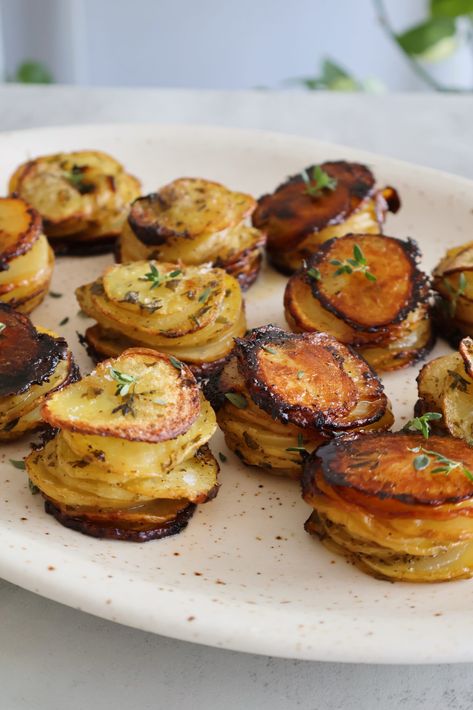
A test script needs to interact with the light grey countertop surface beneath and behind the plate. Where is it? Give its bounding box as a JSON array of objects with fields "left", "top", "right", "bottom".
[{"left": 0, "top": 85, "right": 473, "bottom": 710}]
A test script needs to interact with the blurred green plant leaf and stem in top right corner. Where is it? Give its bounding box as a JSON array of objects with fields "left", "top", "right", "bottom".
[{"left": 373, "top": 0, "right": 473, "bottom": 91}]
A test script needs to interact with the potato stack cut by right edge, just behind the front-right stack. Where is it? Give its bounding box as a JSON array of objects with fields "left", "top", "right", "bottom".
[{"left": 416, "top": 338, "right": 473, "bottom": 444}]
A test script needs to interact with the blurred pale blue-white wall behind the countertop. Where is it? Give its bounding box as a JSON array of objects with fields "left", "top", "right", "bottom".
[{"left": 0, "top": 0, "right": 469, "bottom": 90}]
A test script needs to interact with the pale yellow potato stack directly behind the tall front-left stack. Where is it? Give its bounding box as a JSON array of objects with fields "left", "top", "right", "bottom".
[{"left": 76, "top": 261, "right": 246, "bottom": 377}]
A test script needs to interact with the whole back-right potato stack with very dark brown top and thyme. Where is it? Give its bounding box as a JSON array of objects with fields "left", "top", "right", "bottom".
[{"left": 253, "top": 161, "right": 400, "bottom": 274}]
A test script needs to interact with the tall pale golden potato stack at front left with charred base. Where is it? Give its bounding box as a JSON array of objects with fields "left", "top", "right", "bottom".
[{"left": 26, "top": 348, "right": 218, "bottom": 541}]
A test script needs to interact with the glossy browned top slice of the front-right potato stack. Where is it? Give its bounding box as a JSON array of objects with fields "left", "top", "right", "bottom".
[{"left": 302, "top": 432, "right": 473, "bottom": 506}]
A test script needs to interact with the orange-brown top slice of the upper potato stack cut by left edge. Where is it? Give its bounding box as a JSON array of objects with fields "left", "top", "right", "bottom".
[{"left": 0, "top": 197, "right": 42, "bottom": 271}]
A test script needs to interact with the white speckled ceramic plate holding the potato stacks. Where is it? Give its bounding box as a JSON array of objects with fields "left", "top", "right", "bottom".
[{"left": 0, "top": 125, "right": 473, "bottom": 663}]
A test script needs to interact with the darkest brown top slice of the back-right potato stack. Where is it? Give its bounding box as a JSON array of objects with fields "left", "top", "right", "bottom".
[{"left": 253, "top": 161, "right": 386, "bottom": 250}]
